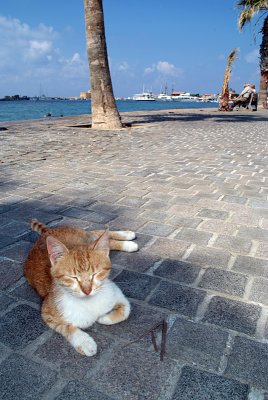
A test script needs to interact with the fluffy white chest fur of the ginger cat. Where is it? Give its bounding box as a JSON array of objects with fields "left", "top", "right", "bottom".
[{"left": 56, "top": 279, "right": 124, "bottom": 328}]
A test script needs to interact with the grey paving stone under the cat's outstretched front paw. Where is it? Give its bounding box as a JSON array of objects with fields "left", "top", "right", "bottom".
[{"left": 34, "top": 330, "right": 114, "bottom": 379}]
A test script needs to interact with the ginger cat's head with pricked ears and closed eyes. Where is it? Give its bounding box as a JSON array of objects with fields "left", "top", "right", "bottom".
[{"left": 46, "top": 232, "right": 111, "bottom": 297}]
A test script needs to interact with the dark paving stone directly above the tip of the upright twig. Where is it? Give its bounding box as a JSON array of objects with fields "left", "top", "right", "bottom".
[{"left": 149, "top": 282, "right": 205, "bottom": 317}]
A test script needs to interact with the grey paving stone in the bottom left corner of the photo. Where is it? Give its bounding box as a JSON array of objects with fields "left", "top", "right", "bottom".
[{"left": 0, "top": 354, "right": 56, "bottom": 400}]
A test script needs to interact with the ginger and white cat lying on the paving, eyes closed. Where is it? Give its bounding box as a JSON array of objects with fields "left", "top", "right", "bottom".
[{"left": 24, "top": 220, "right": 138, "bottom": 356}]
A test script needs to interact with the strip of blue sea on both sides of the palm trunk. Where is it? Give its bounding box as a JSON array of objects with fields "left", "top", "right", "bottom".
[{"left": 0, "top": 100, "right": 218, "bottom": 122}]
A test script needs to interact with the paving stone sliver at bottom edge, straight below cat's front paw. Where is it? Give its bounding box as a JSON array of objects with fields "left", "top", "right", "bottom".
[{"left": 55, "top": 381, "right": 112, "bottom": 400}]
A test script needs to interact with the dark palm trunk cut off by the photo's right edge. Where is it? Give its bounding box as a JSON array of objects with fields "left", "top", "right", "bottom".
[{"left": 259, "top": 17, "right": 268, "bottom": 108}]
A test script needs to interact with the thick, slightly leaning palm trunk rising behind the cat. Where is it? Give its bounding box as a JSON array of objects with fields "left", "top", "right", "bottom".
[{"left": 84, "top": 0, "right": 122, "bottom": 129}]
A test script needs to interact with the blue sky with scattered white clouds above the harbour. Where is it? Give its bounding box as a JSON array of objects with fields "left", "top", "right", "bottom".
[{"left": 0, "top": 0, "right": 261, "bottom": 97}]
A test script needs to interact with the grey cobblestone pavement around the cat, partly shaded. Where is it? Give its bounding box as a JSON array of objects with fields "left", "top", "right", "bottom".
[{"left": 0, "top": 110, "right": 268, "bottom": 400}]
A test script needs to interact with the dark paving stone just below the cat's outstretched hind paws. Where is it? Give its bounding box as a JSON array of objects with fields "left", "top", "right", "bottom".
[{"left": 110, "top": 250, "right": 160, "bottom": 272}]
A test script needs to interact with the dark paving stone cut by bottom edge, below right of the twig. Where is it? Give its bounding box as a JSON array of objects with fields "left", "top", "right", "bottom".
[{"left": 172, "top": 367, "right": 249, "bottom": 400}]
